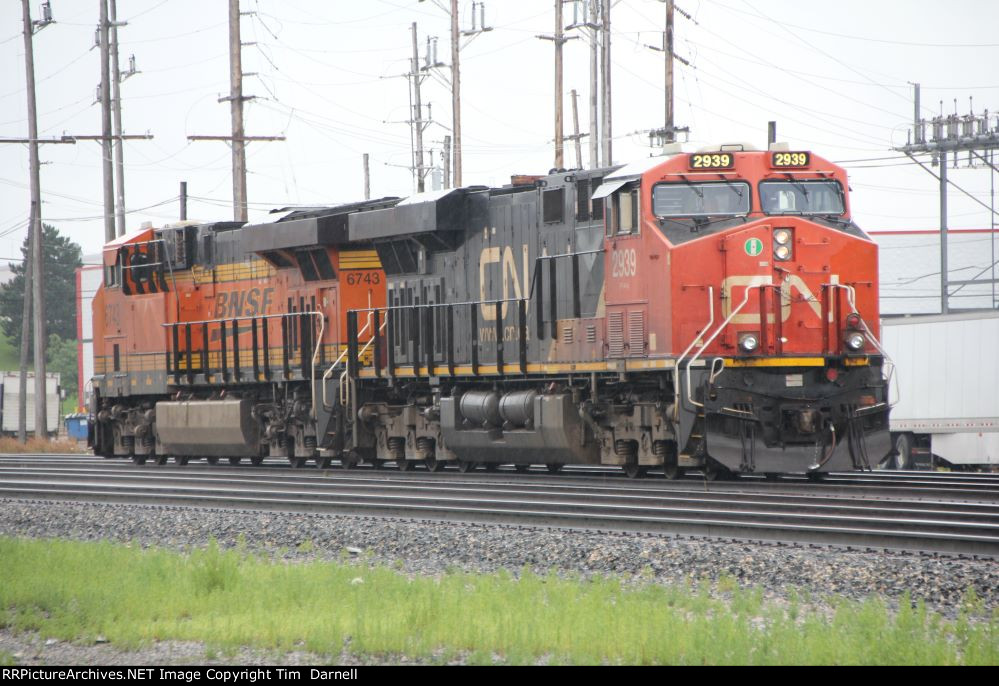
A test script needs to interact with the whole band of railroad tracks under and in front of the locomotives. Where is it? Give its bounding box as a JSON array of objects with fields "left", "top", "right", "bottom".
[{"left": 0, "top": 456, "right": 999, "bottom": 557}]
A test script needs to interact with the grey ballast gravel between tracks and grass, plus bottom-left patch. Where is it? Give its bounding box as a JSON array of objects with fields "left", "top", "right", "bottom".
[{"left": 0, "top": 500, "right": 999, "bottom": 664}]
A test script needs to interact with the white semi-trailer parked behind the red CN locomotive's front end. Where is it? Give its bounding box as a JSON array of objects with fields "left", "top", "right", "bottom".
[{"left": 881, "top": 311, "right": 999, "bottom": 469}]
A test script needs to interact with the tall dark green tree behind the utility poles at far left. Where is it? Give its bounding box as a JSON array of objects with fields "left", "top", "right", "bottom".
[{"left": 0, "top": 224, "right": 83, "bottom": 350}]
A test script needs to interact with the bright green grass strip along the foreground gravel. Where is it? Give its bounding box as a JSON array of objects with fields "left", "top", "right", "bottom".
[{"left": 0, "top": 539, "right": 999, "bottom": 665}]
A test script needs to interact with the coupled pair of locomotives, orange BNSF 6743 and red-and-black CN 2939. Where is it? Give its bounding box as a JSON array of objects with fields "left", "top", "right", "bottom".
[{"left": 92, "top": 145, "right": 890, "bottom": 478}]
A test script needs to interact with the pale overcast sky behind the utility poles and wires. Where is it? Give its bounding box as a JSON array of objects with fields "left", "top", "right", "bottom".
[{"left": 0, "top": 0, "right": 999, "bottom": 312}]
